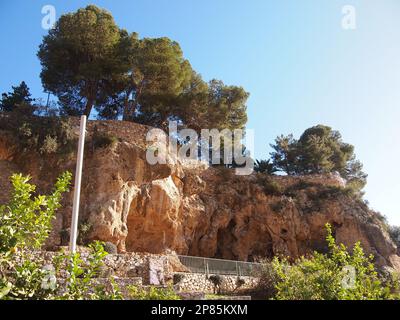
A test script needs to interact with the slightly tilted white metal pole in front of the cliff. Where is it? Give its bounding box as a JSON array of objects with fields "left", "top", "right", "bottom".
[{"left": 69, "top": 116, "right": 86, "bottom": 253}]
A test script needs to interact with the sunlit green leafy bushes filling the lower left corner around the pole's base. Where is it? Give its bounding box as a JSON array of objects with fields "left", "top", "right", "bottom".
[{"left": 0, "top": 172, "right": 122, "bottom": 299}]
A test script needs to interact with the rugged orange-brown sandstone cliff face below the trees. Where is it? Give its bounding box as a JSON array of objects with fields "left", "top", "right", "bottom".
[{"left": 0, "top": 121, "right": 400, "bottom": 269}]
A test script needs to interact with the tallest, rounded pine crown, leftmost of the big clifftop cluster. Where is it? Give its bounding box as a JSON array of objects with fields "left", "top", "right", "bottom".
[{"left": 38, "top": 5, "right": 121, "bottom": 115}]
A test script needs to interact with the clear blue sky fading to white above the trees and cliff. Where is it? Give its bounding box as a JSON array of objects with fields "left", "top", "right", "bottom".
[{"left": 0, "top": 0, "right": 400, "bottom": 225}]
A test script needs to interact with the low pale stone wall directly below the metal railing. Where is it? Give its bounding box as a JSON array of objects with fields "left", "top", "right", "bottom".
[{"left": 174, "top": 272, "right": 258, "bottom": 293}]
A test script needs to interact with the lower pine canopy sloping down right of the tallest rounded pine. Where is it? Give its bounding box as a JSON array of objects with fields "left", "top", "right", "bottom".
[{"left": 97, "top": 33, "right": 248, "bottom": 131}]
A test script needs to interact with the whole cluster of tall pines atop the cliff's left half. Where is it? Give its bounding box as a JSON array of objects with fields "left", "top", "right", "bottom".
[{"left": 38, "top": 5, "right": 249, "bottom": 131}]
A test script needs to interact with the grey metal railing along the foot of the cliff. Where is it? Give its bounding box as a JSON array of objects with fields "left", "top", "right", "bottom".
[{"left": 178, "top": 255, "right": 261, "bottom": 276}]
